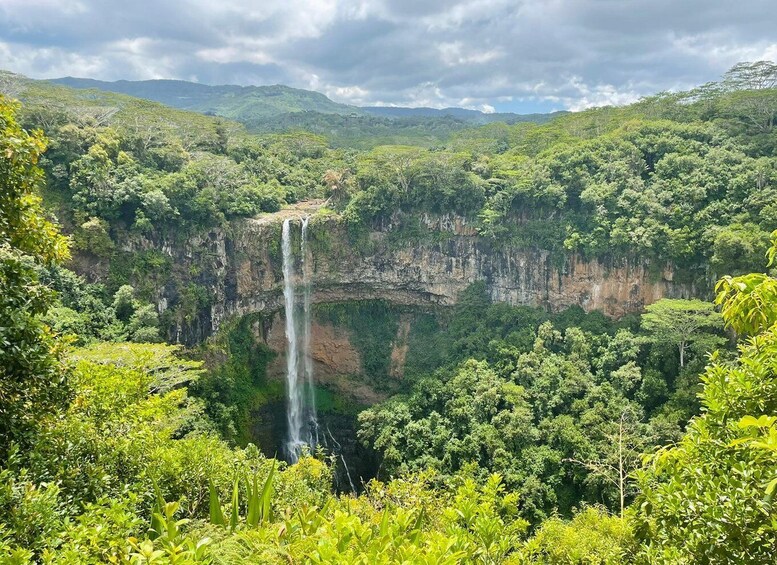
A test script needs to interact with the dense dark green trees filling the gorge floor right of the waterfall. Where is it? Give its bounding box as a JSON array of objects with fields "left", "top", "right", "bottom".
[{"left": 358, "top": 284, "right": 712, "bottom": 522}]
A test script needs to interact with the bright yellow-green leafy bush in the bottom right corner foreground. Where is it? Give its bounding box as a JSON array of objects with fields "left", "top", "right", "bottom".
[{"left": 637, "top": 330, "right": 777, "bottom": 563}]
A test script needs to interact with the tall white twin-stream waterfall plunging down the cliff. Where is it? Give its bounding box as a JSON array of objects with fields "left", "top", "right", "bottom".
[{"left": 281, "top": 217, "right": 318, "bottom": 463}]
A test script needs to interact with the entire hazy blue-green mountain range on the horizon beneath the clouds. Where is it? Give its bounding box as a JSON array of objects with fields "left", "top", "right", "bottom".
[{"left": 51, "top": 77, "right": 553, "bottom": 149}]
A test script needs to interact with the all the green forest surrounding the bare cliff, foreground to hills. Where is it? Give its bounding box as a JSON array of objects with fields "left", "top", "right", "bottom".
[{"left": 0, "top": 62, "right": 777, "bottom": 564}]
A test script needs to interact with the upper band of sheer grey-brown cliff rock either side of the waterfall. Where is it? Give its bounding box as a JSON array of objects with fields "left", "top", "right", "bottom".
[{"left": 158, "top": 207, "right": 697, "bottom": 342}]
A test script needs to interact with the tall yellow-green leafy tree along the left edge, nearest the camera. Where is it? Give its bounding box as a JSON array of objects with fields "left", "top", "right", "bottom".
[{"left": 0, "top": 96, "right": 68, "bottom": 463}]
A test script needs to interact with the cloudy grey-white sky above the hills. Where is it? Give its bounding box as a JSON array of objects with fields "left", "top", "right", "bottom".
[{"left": 0, "top": 0, "right": 777, "bottom": 112}]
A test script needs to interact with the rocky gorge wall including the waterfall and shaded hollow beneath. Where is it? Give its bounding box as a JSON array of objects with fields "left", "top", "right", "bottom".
[{"left": 116, "top": 201, "right": 702, "bottom": 480}]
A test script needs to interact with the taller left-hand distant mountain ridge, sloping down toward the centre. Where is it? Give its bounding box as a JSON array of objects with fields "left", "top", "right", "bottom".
[{"left": 51, "top": 77, "right": 363, "bottom": 122}]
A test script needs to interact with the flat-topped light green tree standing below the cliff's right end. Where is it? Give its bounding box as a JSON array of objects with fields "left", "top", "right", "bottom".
[{"left": 642, "top": 298, "right": 722, "bottom": 367}]
